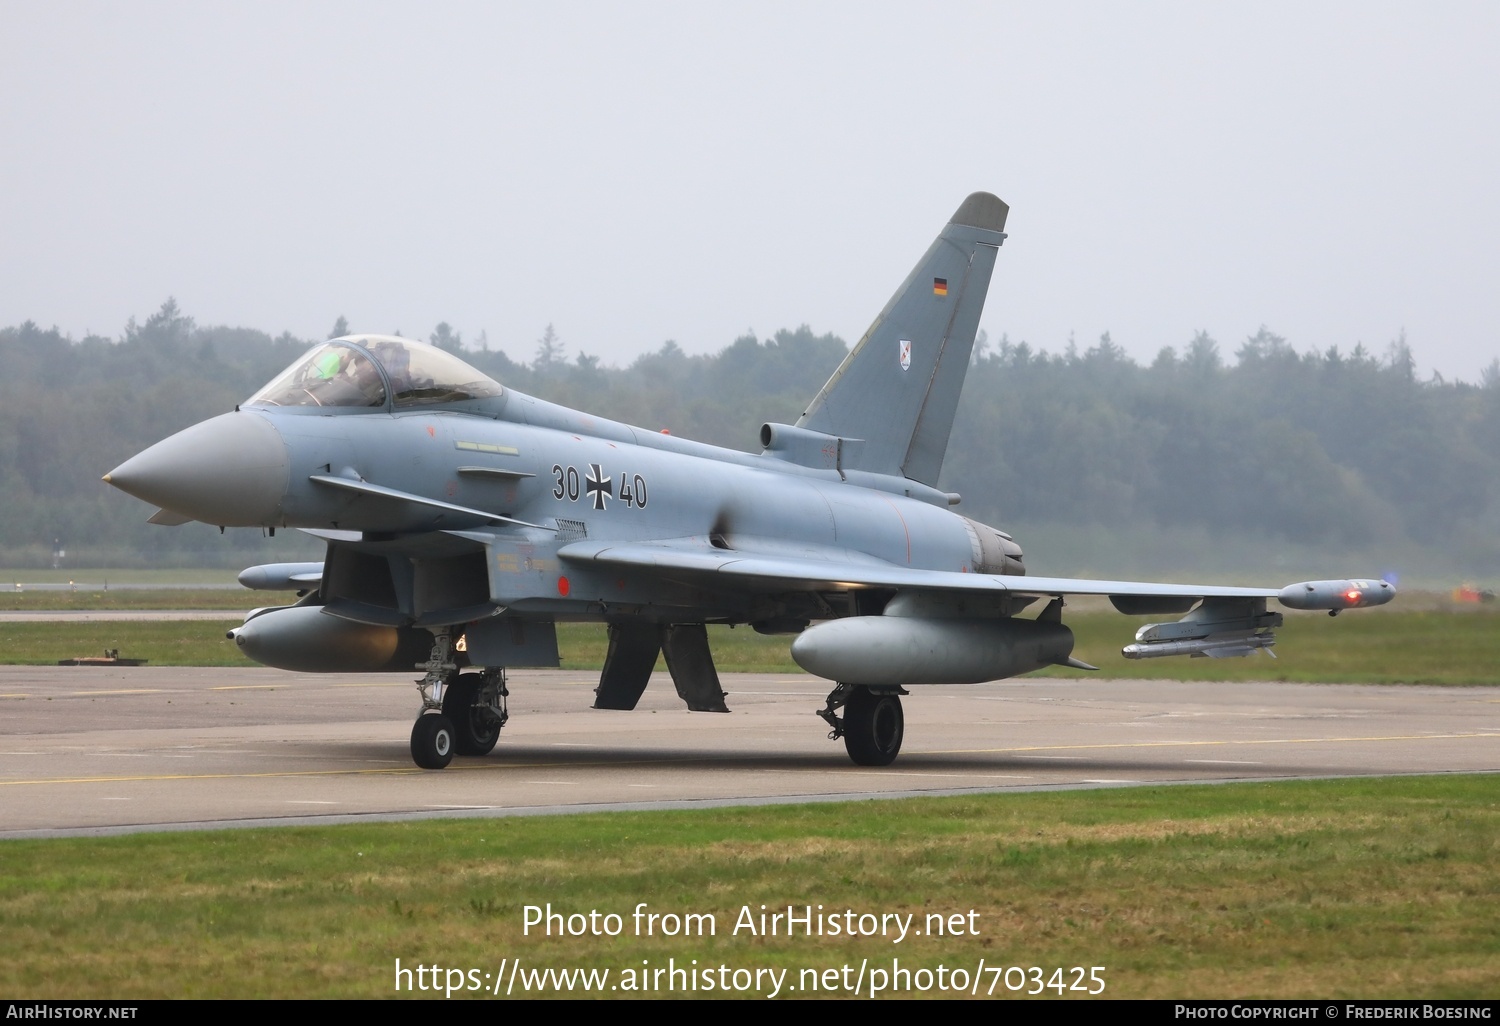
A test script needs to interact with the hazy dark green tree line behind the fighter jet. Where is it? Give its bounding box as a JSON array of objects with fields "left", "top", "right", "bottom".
[{"left": 0, "top": 300, "right": 1500, "bottom": 576}]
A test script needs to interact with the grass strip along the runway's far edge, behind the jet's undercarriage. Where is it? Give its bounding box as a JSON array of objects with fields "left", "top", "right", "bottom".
[{"left": 0, "top": 606, "right": 1500, "bottom": 684}]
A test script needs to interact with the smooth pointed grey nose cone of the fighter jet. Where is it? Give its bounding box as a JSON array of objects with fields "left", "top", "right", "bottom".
[{"left": 104, "top": 411, "right": 291, "bottom": 527}]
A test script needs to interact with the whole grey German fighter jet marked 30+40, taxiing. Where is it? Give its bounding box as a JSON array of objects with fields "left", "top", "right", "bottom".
[{"left": 104, "top": 192, "right": 1395, "bottom": 768}]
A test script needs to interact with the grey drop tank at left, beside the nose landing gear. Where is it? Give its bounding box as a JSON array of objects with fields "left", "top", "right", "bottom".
[{"left": 228, "top": 606, "right": 432, "bottom": 674}]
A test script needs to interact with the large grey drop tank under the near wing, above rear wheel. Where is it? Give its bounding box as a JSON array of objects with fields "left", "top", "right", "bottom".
[{"left": 792, "top": 615, "right": 1092, "bottom": 686}]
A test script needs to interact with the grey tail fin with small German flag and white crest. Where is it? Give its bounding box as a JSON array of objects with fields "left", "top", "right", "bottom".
[{"left": 797, "top": 192, "right": 1010, "bottom": 485}]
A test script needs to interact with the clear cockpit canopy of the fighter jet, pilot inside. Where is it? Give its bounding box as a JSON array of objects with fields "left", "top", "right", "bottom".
[{"left": 245, "top": 335, "right": 504, "bottom": 410}]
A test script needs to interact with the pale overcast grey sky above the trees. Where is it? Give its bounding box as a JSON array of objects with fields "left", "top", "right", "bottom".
[{"left": 0, "top": 0, "right": 1500, "bottom": 381}]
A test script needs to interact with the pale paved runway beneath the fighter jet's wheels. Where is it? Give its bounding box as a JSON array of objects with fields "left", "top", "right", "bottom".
[{"left": 0, "top": 666, "right": 1500, "bottom": 837}]
